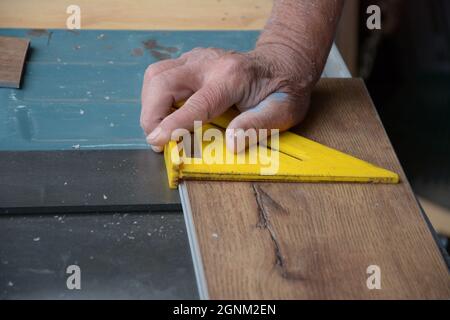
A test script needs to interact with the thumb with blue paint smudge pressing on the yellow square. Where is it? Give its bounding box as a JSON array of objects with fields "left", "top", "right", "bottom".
[{"left": 226, "top": 92, "right": 307, "bottom": 153}]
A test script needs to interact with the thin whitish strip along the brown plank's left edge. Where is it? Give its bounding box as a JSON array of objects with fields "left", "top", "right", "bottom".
[{"left": 178, "top": 182, "right": 209, "bottom": 300}]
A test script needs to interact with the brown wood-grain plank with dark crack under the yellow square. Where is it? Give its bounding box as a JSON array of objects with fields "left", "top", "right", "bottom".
[{"left": 186, "top": 79, "right": 450, "bottom": 299}]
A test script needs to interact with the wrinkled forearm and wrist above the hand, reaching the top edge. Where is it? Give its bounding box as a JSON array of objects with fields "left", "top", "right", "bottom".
[{"left": 255, "top": 0, "right": 344, "bottom": 86}]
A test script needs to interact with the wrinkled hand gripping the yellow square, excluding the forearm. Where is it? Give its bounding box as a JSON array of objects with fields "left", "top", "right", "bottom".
[{"left": 141, "top": 48, "right": 317, "bottom": 152}]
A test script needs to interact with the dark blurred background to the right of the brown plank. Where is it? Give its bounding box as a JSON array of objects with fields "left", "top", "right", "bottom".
[{"left": 337, "top": 0, "right": 450, "bottom": 249}]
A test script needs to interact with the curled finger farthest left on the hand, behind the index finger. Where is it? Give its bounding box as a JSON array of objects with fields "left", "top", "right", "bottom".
[{"left": 141, "top": 66, "right": 194, "bottom": 135}]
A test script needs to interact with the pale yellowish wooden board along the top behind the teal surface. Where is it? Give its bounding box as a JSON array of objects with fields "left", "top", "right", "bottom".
[{"left": 0, "top": 0, "right": 273, "bottom": 30}]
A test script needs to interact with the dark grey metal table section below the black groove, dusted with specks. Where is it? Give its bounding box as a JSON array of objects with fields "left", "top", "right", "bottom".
[{"left": 0, "top": 211, "right": 198, "bottom": 299}]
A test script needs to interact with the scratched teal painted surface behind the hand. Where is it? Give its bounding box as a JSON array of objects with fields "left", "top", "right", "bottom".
[{"left": 0, "top": 29, "right": 258, "bottom": 150}]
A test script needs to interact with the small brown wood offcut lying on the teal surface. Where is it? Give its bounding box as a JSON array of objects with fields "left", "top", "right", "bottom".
[{"left": 0, "top": 36, "right": 30, "bottom": 88}]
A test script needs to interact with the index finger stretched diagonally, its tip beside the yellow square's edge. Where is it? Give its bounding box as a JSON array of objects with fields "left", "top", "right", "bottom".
[{"left": 148, "top": 84, "right": 234, "bottom": 147}]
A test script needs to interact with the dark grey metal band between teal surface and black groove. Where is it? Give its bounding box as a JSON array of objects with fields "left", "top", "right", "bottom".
[{"left": 0, "top": 150, "right": 181, "bottom": 214}]
